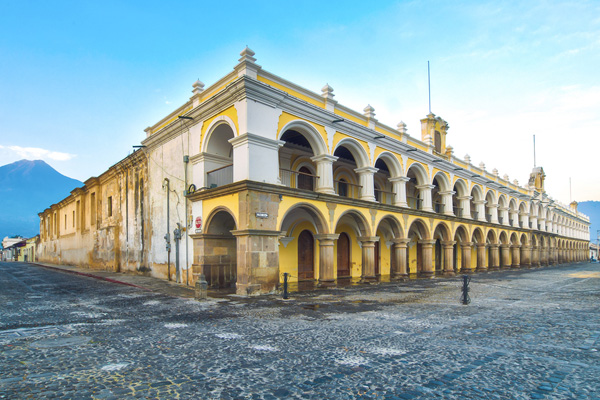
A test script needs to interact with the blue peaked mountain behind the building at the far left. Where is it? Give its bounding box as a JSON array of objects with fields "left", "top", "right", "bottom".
[{"left": 0, "top": 160, "right": 83, "bottom": 240}]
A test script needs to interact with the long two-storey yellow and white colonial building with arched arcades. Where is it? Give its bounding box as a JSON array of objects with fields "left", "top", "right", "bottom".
[{"left": 39, "top": 48, "right": 590, "bottom": 294}]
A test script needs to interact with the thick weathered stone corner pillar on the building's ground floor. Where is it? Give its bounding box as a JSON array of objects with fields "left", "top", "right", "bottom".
[{"left": 231, "top": 229, "right": 281, "bottom": 295}]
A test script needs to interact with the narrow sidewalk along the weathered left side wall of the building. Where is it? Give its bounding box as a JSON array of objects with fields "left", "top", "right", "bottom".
[{"left": 30, "top": 262, "right": 194, "bottom": 298}]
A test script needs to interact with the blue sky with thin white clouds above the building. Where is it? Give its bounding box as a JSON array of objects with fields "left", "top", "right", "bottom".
[{"left": 0, "top": 0, "right": 600, "bottom": 203}]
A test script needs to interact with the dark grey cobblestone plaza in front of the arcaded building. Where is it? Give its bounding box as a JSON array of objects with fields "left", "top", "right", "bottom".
[{"left": 0, "top": 263, "right": 600, "bottom": 399}]
